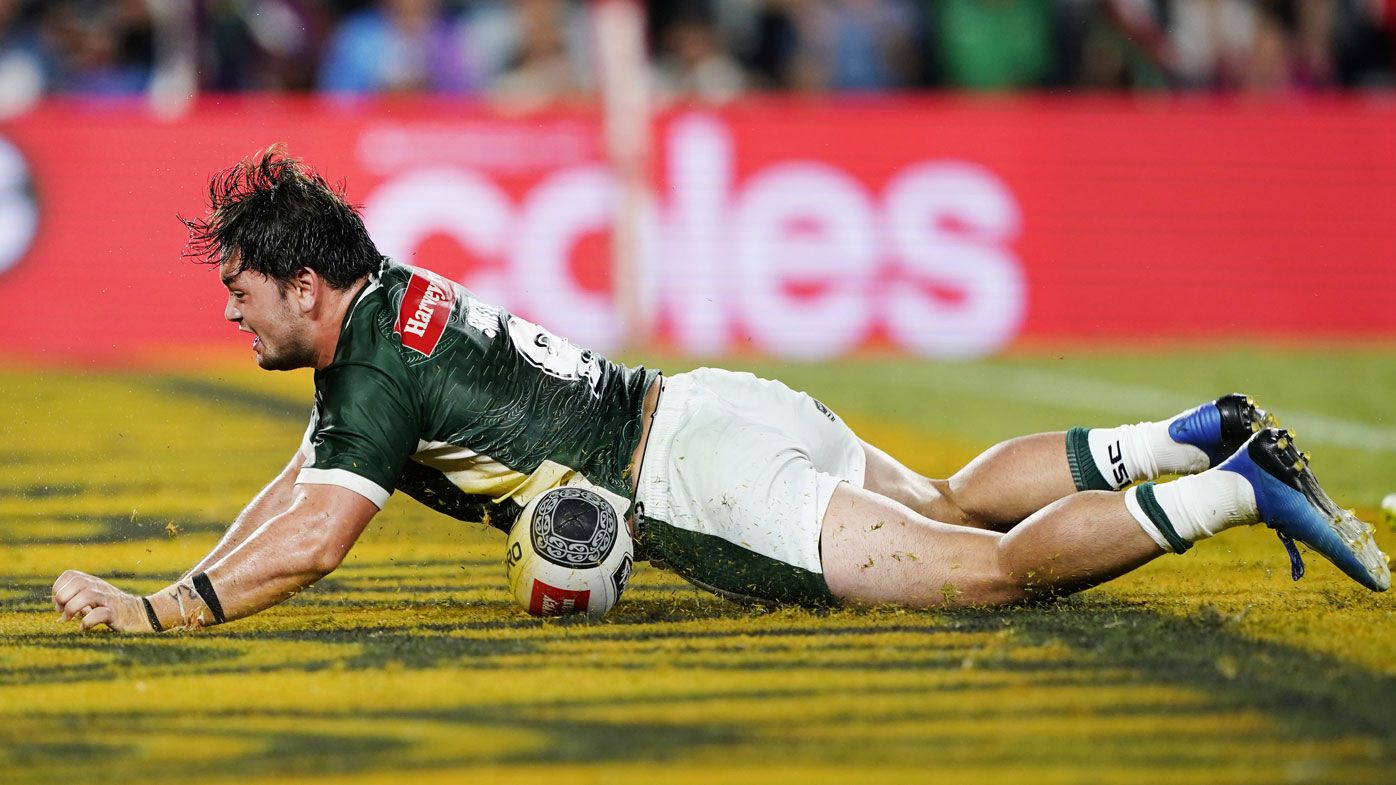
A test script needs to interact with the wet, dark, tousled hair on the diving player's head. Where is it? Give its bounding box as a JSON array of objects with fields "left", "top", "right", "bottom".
[{"left": 179, "top": 144, "right": 383, "bottom": 289}]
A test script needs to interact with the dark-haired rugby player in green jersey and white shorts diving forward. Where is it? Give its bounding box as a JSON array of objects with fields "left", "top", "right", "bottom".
[{"left": 53, "top": 148, "right": 1390, "bottom": 633}]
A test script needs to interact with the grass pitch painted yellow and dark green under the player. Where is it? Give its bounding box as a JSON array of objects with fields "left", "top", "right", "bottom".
[{"left": 0, "top": 348, "right": 1396, "bottom": 785}]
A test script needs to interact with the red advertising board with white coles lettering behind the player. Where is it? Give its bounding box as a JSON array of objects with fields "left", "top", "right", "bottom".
[{"left": 0, "top": 98, "right": 1396, "bottom": 362}]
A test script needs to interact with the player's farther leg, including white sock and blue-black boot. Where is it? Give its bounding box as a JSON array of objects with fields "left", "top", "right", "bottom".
[{"left": 863, "top": 394, "right": 1275, "bottom": 531}]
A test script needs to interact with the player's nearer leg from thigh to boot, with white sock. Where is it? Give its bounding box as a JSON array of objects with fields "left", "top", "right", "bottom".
[{"left": 821, "top": 429, "right": 1390, "bottom": 608}]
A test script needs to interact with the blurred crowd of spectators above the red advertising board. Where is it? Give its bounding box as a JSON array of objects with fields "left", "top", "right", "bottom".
[{"left": 0, "top": 0, "right": 1396, "bottom": 113}]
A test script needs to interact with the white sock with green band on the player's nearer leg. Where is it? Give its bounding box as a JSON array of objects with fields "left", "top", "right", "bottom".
[{"left": 1125, "top": 469, "right": 1259, "bottom": 553}]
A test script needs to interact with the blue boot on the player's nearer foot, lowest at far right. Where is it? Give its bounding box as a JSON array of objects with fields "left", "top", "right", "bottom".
[{"left": 1217, "top": 427, "right": 1392, "bottom": 591}]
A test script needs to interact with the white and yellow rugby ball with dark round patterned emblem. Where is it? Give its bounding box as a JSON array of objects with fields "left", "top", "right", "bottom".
[{"left": 504, "top": 486, "right": 635, "bottom": 616}]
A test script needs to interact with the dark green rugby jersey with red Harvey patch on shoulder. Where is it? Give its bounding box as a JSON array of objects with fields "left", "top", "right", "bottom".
[{"left": 296, "top": 258, "right": 658, "bottom": 531}]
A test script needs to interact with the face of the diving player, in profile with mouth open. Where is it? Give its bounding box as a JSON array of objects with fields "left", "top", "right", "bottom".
[{"left": 219, "top": 255, "right": 315, "bottom": 370}]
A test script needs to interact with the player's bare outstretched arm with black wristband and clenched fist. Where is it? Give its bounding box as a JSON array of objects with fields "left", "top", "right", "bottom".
[{"left": 53, "top": 485, "right": 378, "bottom": 633}]
